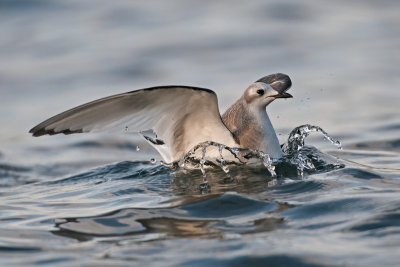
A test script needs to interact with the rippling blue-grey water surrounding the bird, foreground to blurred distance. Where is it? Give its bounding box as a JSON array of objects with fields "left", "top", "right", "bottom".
[{"left": 0, "top": 0, "right": 400, "bottom": 266}]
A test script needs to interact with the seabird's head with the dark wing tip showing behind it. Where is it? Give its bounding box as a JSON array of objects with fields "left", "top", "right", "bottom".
[{"left": 243, "top": 73, "right": 293, "bottom": 108}]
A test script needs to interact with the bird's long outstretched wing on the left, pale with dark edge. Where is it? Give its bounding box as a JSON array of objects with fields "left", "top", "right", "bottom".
[{"left": 29, "top": 86, "right": 237, "bottom": 162}]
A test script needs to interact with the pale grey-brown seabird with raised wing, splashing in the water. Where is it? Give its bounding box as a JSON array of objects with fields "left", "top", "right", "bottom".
[{"left": 29, "top": 73, "right": 293, "bottom": 163}]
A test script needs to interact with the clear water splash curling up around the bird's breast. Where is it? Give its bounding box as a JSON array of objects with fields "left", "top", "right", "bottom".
[{"left": 165, "top": 124, "right": 342, "bottom": 180}]
